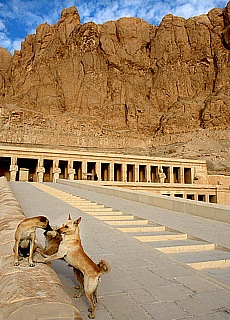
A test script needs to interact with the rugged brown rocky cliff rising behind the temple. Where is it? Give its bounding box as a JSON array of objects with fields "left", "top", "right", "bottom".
[{"left": 0, "top": 2, "right": 230, "bottom": 173}]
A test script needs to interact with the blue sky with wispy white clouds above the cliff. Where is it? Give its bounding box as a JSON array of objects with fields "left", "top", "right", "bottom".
[{"left": 0, "top": 0, "right": 228, "bottom": 54}]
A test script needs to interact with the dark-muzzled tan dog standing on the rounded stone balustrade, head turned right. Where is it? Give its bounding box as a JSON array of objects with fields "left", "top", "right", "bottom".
[{"left": 13, "top": 216, "right": 52, "bottom": 267}]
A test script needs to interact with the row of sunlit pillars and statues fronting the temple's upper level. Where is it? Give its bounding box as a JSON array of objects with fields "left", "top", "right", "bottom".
[{"left": 10, "top": 157, "right": 195, "bottom": 184}]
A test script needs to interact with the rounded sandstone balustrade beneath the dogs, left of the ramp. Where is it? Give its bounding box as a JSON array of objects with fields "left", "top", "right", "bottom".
[{"left": 0, "top": 177, "right": 82, "bottom": 320}]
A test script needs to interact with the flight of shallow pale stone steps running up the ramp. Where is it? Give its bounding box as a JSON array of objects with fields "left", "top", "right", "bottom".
[{"left": 34, "top": 183, "right": 230, "bottom": 274}]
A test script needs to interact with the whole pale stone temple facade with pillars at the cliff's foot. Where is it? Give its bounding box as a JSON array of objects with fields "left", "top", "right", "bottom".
[{"left": 0, "top": 145, "right": 230, "bottom": 205}]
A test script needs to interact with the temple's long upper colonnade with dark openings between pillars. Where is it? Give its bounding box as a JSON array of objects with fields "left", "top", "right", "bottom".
[{"left": 0, "top": 156, "right": 199, "bottom": 184}]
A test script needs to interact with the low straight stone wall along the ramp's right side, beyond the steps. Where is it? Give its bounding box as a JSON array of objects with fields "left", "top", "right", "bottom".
[{"left": 57, "top": 179, "right": 230, "bottom": 223}]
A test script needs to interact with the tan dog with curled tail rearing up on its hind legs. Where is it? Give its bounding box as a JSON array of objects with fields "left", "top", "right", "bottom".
[{"left": 44, "top": 217, "right": 110, "bottom": 319}]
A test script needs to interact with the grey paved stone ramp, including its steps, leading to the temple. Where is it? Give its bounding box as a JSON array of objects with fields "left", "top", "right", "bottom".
[{"left": 10, "top": 182, "right": 230, "bottom": 320}]
